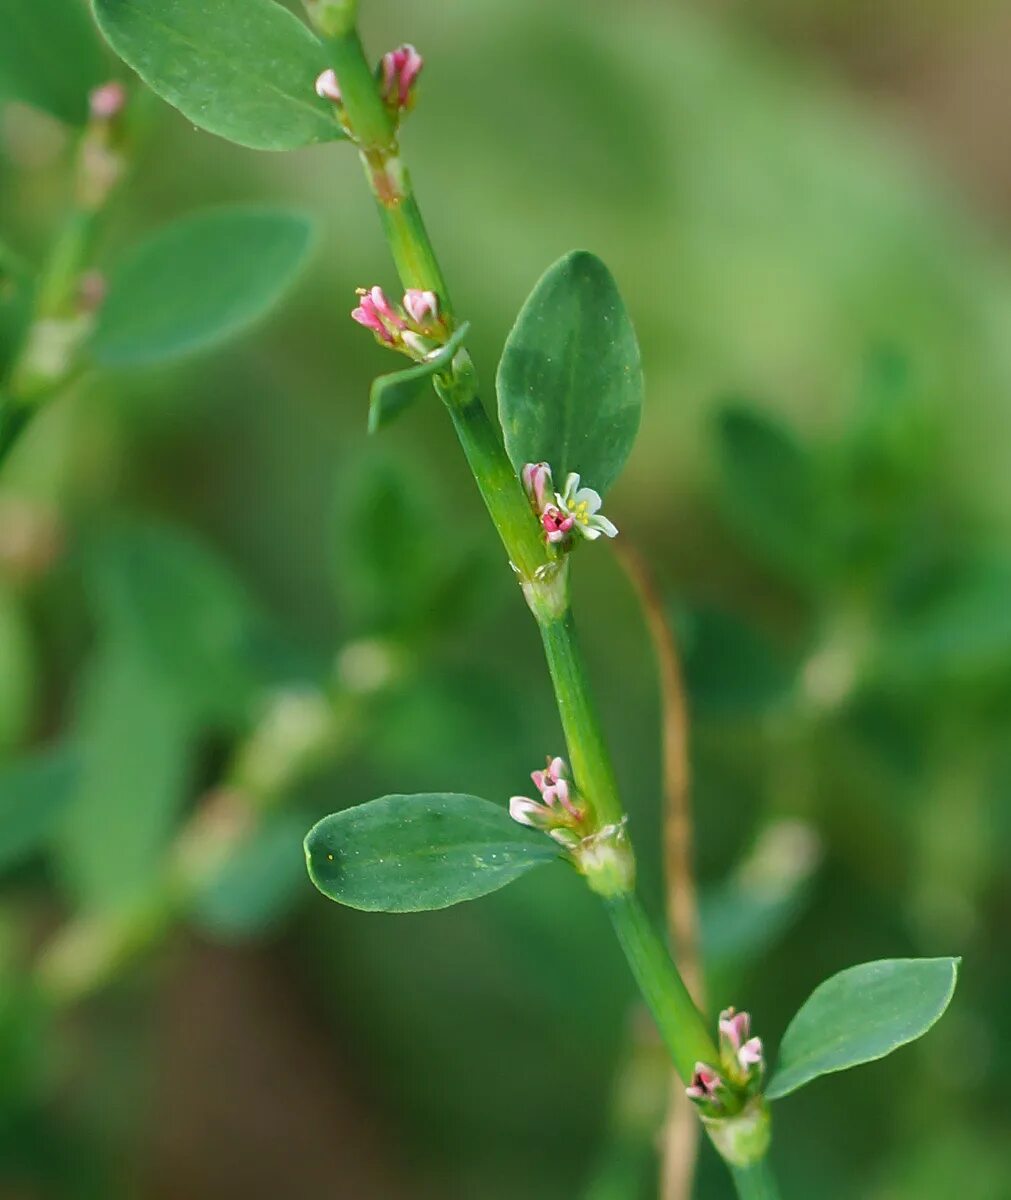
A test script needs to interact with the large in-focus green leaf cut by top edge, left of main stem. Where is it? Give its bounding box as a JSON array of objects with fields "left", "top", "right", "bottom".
[{"left": 92, "top": 0, "right": 343, "bottom": 150}]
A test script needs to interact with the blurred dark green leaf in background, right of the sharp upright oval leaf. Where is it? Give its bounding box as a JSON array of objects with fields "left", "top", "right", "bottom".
[{"left": 716, "top": 403, "right": 827, "bottom": 582}]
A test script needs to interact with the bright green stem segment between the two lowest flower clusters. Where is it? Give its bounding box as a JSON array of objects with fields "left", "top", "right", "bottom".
[{"left": 608, "top": 895, "right": 719, "bottom": 1084}]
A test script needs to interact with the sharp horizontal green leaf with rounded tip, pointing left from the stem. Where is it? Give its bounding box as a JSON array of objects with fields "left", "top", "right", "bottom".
[{"left": 305, "top": 792, "right": 560, "bottom": 912}]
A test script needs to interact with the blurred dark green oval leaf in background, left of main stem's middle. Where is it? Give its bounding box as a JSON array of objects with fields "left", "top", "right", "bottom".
[{"left": 334, "top": 454, "right": 444, "bottom": 634}]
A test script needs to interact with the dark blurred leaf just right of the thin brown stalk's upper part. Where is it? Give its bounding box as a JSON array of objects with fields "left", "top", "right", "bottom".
[{"left": 683, "top": 608, "right": 794, "bottom": 716}]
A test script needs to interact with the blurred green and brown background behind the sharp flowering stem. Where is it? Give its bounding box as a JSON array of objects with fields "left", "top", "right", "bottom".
[{"left": 0, "top": 0, "right": 1011, "bottom": 1200}]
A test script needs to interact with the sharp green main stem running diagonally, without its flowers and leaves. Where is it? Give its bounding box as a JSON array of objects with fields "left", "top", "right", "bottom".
[{"left": 321, "top": 25, "right": 778, "bottom": 1198}]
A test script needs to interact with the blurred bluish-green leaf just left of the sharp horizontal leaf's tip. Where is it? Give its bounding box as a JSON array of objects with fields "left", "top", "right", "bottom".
[{"left": 191, "top": 812, "right": 311, "bottom": 941}]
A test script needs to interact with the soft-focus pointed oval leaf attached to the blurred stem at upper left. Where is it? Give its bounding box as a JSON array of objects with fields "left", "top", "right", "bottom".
[{"left": 90, "top": 206, "right": 312, "bottom": 367}]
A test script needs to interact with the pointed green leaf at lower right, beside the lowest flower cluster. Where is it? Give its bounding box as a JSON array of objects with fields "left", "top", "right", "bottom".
[{"left": 766, "top": 959, "right": 961, "bottom": 1100}]
